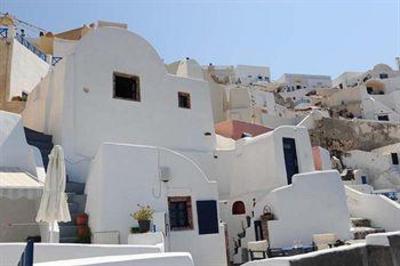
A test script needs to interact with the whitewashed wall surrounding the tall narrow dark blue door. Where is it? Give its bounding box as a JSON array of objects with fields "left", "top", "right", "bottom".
[{"left": 216, "top": 126, "right": 315, "bottom": 197}]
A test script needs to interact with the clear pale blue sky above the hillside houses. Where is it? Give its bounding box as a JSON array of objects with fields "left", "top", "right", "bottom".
[{"left": 0, "top": 0, "right": 400, "bottom": 78}]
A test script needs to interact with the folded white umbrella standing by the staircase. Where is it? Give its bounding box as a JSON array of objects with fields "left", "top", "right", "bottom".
[{"left": 36, "top": 145, "right": 71, "bottom": 225}]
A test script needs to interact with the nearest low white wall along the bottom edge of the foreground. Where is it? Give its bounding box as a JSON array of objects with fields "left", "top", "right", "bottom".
[{"left": 35, "top": 253, "right": 194, "bottom": 266}]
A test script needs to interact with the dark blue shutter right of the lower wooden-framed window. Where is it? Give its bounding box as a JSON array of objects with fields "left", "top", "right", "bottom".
[{"left": 196, "top": 200, "right": 219, "bottom": 235}]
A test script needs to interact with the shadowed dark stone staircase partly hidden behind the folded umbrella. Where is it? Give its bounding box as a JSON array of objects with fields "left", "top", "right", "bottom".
[{"left": 24, "top": 128, "right": 86, "bottom": 243}]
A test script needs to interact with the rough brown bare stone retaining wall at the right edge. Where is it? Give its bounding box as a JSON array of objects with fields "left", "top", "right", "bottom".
[{"left": 309, "top": 117, "right": 400, "bottom": 154}]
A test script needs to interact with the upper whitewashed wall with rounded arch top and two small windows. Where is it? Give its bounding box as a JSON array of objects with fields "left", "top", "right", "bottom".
[{"left": 24, "top": 27, "right": 215, "bottom": 181}]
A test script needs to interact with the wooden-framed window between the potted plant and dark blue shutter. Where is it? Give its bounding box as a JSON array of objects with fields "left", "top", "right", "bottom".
[{"left": 168, "top": 196, "right": 193, "bottom": 231}]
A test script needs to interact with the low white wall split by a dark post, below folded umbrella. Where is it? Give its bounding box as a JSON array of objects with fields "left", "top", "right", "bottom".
[{"left": 0, "top": 243, "right": 160, "bottom": 265}]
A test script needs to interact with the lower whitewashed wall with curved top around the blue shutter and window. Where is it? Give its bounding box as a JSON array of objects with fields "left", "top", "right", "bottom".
[{"left": 86, "top": 143, "right": 226, "bottom": 266}]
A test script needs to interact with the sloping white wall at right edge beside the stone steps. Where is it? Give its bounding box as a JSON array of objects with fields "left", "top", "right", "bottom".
[{"left": 346, "top": 186, "right": 400, "bottom": 231}]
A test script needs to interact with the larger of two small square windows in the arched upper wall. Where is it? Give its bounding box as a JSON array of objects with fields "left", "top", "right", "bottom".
[{"left": 113, "top": 73, "right": 140, "bottom": 102}]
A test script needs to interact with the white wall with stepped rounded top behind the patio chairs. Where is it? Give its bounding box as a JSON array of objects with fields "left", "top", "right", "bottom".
[{"left": 255, "top": 170, "right": 352, "bottom": 248}]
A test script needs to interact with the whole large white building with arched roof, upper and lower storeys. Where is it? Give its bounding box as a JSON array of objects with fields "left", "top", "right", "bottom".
[{"left": 23, "top": 22, "right": 226, "bottom": 265}]
